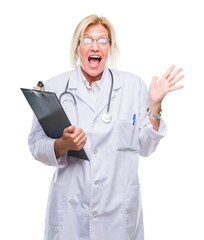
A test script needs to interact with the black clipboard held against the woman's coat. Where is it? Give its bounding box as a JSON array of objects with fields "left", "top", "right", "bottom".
[{"left": 21, "top": 88, "right": 89, "bottom": 161}]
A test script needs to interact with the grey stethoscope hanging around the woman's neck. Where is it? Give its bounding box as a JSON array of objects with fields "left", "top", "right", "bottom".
[{"left": 59, "top": 69, "right": 113, "bottom": 125}]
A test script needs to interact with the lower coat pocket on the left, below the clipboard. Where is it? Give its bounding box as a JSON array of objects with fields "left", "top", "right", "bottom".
[{"left": 46, "top": 182, "right": 68, "bottom": 227}]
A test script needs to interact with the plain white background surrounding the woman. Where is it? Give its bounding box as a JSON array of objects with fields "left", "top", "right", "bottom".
[{"left": 0, "top": 0, "right": 204, "bottom": 240}]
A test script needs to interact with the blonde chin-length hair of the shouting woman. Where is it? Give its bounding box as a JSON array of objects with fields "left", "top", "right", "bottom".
[{"left": 70, "top": 15, "right": 119, "bottom": 67}]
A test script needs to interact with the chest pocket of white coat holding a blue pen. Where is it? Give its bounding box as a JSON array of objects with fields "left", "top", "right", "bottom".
[{"left": 115, "top": 120, "right": 139, "bottom": 151}]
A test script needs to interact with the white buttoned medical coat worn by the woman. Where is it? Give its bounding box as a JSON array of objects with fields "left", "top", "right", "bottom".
[{"left": 29, "top": 66, "right": 166, "bottom": 240}]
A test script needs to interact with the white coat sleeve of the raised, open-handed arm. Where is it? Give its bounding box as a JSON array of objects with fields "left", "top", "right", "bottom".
[{"left": 139, "top": 81, "right": 167, "bottom": 157}]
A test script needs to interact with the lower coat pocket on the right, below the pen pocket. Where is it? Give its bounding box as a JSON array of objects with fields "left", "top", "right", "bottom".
[{"left": 124, "top": 185, "right": 140, "bottom": 228}]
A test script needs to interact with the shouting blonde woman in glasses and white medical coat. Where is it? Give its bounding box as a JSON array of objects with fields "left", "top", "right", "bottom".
[{"left": 29, "top": 15, "right": 183, "bottom": 240}]
